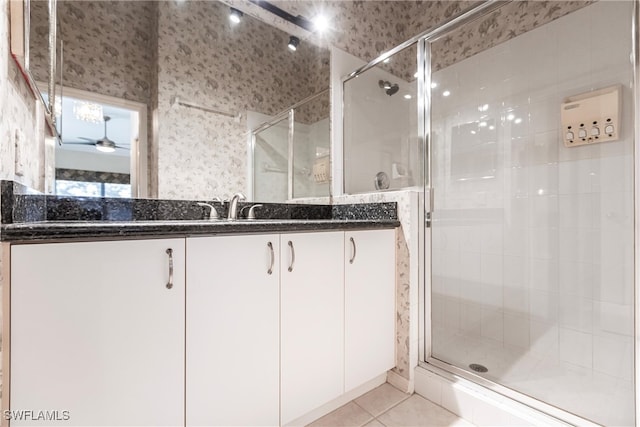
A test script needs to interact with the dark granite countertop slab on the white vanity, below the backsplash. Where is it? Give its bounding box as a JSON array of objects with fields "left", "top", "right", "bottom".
[{"left": 0, "top": 219, "right": 400, "bottom": 243}]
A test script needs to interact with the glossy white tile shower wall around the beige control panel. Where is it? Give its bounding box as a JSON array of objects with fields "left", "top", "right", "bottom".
[{"left": 432, "top": 1, "right": 633, "bottom": 422}]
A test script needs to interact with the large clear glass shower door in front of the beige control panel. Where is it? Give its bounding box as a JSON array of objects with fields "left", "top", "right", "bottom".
[{"left": 427, "top": 1, "right": 636, "bottom": 425}]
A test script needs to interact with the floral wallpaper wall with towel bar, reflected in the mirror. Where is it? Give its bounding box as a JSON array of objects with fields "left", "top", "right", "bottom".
[{"left": 157, "top": 2, "right": 329, "bottom": 198}]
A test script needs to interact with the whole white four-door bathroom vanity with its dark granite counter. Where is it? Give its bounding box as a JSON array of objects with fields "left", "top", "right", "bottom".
[{"left": 2, "top": 186, "right": 398, "bottom": 426}]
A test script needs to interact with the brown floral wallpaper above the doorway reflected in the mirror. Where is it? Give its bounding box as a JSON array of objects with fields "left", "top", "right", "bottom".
[{"left": 58, "top": 0, "right": 155, "bottom": 104}]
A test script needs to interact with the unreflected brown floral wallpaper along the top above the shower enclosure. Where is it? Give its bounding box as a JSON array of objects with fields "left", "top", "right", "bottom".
[{"left": 274, "top": 0, "right": 593, "bottom": 88}]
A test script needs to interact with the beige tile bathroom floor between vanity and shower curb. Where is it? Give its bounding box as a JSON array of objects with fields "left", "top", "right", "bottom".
[{"left": 309, "top": 383, "right": 473, "bottom": 427}]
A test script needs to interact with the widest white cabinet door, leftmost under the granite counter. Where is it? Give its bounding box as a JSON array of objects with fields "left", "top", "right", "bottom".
[{"left": 10, "top": 239, "right": 184, "bottom": 426}]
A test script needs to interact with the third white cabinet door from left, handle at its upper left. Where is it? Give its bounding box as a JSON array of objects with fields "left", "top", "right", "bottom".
[{"left": 280, "top": 232, "right": 344, "bottom": 424}]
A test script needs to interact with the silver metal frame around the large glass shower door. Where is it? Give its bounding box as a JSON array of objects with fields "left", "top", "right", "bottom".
[{"left": 416, "top": 0, "right": 640, "bottom": 426}]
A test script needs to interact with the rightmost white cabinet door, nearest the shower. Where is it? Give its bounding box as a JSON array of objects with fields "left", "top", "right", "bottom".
[{"left": 344, "top": 230, "right": 396, "bottom": 391}]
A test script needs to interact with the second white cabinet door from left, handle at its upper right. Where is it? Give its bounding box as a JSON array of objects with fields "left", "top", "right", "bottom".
[{"left": 186, "top": 235, "right": 280, "bottom": 426}]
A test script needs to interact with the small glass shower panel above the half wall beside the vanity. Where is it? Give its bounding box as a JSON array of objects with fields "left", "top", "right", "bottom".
[{"left": 343, "top": 43, "right": 424, "bottom": 194}]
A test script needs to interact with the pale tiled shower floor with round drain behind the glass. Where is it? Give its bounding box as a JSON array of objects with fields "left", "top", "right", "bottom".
[{"left": 433, "top": 328, "right": 634, "bottom": 426}]
